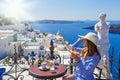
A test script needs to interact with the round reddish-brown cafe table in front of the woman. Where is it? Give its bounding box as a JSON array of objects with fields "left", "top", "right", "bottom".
[{"left": 29, "top": 64, "right": 67, "bottom": 79}]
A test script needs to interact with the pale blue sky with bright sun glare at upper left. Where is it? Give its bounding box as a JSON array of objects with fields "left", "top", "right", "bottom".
[{"left": 0, "top": 0, "right": 120, "bottom": 20}]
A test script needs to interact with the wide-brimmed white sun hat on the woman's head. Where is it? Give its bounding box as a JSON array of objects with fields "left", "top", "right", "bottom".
[{"left": 78, "top": 32, "right": 98, "bottom": 46}]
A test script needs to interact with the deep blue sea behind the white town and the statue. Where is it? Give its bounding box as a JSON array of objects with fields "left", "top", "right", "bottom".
[{"left": 30, "top": 21, "right": 120, "bottom": 80}]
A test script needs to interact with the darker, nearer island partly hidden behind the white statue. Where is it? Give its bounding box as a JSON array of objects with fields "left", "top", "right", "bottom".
[{"left": 83, "top": 24, "right": 120, "bottom": 34}]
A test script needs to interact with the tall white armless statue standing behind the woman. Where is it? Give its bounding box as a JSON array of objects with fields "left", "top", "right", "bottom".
[{"left": 94, "top": 13, "right": 112, "bottom": 79}]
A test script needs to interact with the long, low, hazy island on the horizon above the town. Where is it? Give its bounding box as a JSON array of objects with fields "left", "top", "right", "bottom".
[{"left": 29, "top": 20, "right": 84, "bottom": 24}]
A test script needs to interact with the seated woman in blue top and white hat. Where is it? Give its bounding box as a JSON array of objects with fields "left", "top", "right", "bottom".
[{"left": 64, "top": 32, "right": 101, "bottom": 80}]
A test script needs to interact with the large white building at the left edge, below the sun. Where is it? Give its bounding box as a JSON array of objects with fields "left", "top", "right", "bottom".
[{"left": 0, "top": 30, "right": 17, "bottom": 53}]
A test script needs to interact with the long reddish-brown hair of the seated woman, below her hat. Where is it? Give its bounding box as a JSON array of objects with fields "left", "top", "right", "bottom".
[{"left": 82, "top": 39, "right": 100, "bottom": 58}]
